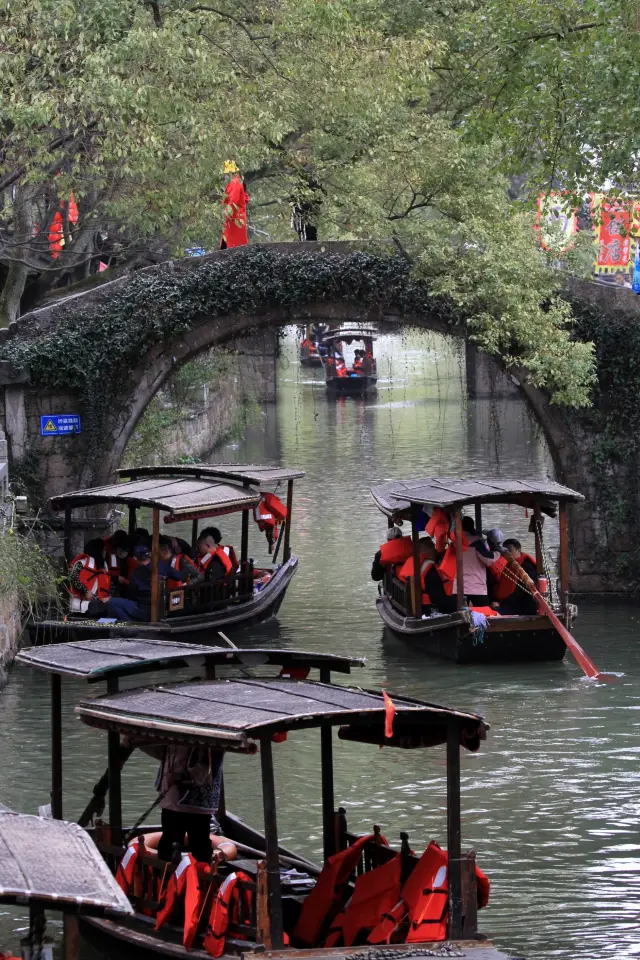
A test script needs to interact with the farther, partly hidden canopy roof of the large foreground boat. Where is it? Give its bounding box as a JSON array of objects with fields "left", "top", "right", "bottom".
[{"left": 17, "top": 639, "right": 366, "bottom": 683}]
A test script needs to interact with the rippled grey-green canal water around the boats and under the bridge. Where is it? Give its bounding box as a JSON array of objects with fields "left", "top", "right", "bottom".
[{"left": 0, "top": 331, "right": 640, "bottom": 960}]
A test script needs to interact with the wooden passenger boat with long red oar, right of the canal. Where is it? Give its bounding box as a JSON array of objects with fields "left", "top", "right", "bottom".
[{"left": 371, "top": 477, "right": 584, "bottom": 663}]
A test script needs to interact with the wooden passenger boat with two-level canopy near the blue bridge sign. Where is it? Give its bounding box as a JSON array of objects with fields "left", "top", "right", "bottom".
[{"left": 30, "top": 463, "right": 304, "bottom": 641}]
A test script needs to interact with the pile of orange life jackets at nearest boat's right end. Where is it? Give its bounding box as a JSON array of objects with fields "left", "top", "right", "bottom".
[{"left": 293, "top": 834, "right": 490, "bottom": 947}]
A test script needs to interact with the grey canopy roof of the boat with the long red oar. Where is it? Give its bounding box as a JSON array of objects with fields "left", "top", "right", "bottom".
[{"left": 371, "top": 477, "right": 584, "bottom": 516}]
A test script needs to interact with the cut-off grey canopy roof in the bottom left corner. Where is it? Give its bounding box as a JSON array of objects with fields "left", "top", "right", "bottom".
[{"left": 0, "top": 810, "right": 133, "bottom": 916}]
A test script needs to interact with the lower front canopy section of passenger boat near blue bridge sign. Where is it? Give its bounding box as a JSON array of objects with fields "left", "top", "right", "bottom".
[{"left": 50, "top": 477, "right": 260, "bottom": 517}]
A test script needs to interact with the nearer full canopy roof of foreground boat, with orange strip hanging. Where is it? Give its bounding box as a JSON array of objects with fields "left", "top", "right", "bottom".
[{"left": 76, "top": 677, "right": 488, "bottom": 753}]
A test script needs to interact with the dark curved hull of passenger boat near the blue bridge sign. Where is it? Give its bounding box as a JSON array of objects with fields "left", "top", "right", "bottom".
[{"left": 29, "top": 557, "right": 298, "bottom": 643}]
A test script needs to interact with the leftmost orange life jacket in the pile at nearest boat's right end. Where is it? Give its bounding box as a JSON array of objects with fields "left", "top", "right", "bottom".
[{"left": 293, "top": 834, "right": 386, "bottom": 947}]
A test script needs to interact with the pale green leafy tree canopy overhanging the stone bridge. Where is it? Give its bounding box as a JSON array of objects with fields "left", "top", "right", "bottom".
[{"left": 0, "top": 0, "right": 608, "bottom": 405}]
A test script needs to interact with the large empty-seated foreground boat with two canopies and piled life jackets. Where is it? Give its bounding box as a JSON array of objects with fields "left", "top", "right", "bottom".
[{"left": 18, "top": 638, "right": 506, "bottom": 960}]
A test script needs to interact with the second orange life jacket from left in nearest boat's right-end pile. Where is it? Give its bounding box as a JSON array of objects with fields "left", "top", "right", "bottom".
[{"left": 324, "top": 853, "right": 402, "bottom": 947}]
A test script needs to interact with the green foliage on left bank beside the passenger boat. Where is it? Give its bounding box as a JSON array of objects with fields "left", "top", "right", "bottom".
[{"left": 0, "top": 528, "right": 61, "bottom": 619}]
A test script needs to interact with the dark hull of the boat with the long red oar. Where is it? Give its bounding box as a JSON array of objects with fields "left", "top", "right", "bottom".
[{"left": 376, "top": 594, "right": 567, "bottom": 663}]
